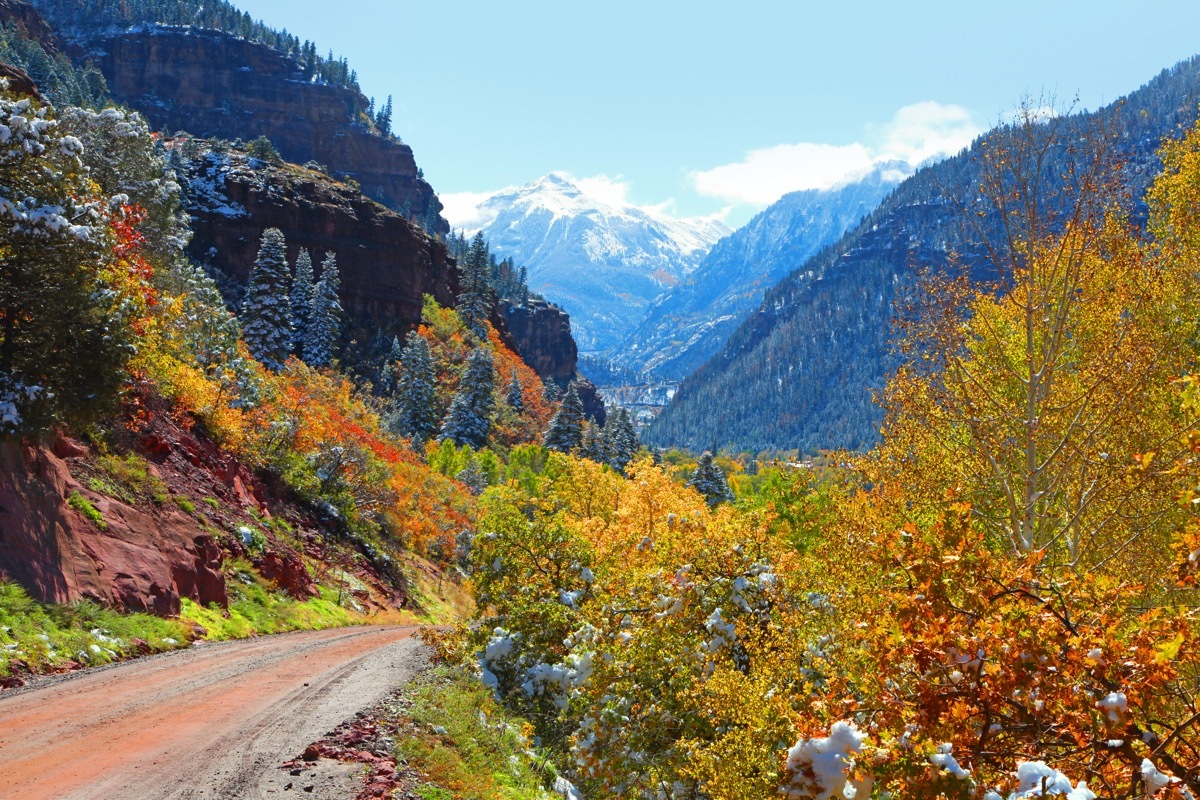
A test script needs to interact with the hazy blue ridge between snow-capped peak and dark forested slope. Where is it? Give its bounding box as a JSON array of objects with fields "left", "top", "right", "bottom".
[{"left": 613, "top": 162, "right": 912, "bottom": 380}]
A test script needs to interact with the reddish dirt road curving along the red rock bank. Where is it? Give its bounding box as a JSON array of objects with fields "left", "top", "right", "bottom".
[{"left": 0, "top": 627, "right": 425, "bottom": 800}]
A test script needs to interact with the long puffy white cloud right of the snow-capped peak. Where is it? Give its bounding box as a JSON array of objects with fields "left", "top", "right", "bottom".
[{"left": 691, "top": 101, "right": 979, "bottom": 205}]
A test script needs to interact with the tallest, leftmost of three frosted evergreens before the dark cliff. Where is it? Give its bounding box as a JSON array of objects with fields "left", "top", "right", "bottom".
[{"left": 241, "top": 228, "right": 292, "bottom": 371}]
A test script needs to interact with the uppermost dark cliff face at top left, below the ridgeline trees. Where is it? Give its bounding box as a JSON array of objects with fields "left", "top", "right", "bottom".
[{"left": 91, "top": 26, "right": 449, "bottom": 225}]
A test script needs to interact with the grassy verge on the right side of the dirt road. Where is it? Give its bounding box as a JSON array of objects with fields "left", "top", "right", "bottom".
[{"left": 396, "top": 667, "right": 558, "bottom": 800}]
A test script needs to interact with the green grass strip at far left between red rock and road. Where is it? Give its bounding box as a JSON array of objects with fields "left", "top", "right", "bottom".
[{"left": 0, "top": 582, "right": 190, "bottom": 675}]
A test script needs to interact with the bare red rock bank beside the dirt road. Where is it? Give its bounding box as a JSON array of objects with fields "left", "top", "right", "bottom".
[{"left": 0, "top": 398, "right": 417, "bottom": 615}]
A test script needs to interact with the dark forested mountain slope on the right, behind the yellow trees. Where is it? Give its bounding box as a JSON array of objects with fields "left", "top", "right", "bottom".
[{"left": 644, "top": 58, "right": 1200, "bottom": 451}]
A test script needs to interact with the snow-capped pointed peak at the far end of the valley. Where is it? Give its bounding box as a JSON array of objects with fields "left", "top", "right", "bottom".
[{"left": 468, "top": 173, "right": 730, "bottom": 350}]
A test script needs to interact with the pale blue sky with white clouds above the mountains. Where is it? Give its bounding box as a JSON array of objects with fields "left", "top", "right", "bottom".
[{"left": 234, "top": 0, "right": 1200, "bottom": 225}]
